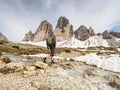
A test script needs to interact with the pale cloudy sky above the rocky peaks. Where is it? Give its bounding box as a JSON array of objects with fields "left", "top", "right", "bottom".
[{"left": 0, "top": 0, "right": 120, "bottom": 41}]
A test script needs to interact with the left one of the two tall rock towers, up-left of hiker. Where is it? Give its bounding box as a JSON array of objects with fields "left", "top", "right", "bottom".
[{"left": 33, "top": 20, "right": 53, "bottom": 42}]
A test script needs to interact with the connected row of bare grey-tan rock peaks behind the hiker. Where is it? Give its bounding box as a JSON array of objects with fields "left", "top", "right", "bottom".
[{"left": 23, "top": 16, "right": 120, "bottom": 42}]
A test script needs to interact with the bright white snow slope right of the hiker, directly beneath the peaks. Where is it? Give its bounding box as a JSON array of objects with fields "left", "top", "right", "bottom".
[{"left": 58, "top": 36, "right": 109, "bottom": 48}]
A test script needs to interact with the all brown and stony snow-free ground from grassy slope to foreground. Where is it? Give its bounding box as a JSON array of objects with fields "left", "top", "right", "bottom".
[{"left": 0, "top": 43, "right": 120, "bottom": 90}]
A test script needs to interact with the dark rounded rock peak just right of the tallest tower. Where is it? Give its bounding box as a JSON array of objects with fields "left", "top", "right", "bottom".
[{"left": 75, "top": 25, "right": 91, "bottom": 41}]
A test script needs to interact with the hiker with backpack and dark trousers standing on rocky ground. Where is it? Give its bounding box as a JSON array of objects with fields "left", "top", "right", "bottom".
[{"left": 44, "top": 32, "right": 56, "bottom": 64}]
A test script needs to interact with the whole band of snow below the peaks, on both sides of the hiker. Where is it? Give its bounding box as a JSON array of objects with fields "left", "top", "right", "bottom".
[{"left": 21, "top": 36, "right": 120, "bottom": 48}]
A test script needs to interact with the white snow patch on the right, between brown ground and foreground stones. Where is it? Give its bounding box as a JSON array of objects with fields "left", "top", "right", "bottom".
[{"left": 74, "top": 53, "right": 120, "bottom": 72}]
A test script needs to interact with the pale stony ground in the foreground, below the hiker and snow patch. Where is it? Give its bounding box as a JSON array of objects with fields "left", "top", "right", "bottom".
[{"left": 0, "top": 53, "right": 120, "bottom": 90}]
